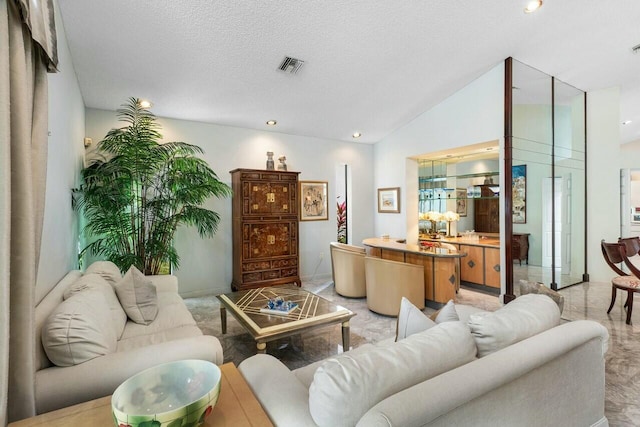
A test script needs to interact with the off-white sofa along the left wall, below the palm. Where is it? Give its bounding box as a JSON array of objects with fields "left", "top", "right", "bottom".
[{"left": 35, "top": 267, "right": 223, "bottom": 413}]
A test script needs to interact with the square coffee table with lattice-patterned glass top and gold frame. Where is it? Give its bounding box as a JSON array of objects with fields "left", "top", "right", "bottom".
[{"left": 217, "top": 286, "right": 356, "bottom": 353}]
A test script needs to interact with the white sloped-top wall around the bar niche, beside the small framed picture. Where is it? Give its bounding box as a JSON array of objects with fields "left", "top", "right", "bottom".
[{"left": 372, "top": 62, "right": 504, "bottom": 239}]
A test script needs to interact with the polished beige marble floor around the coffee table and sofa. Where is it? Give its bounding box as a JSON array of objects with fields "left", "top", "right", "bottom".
[{"left": 185, "top": 281, "right": 640, "bottom": 427}]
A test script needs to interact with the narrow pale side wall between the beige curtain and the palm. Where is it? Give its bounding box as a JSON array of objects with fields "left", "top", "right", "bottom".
[{"left": 36, "top": 2, "right": 84, "bottom": 300}]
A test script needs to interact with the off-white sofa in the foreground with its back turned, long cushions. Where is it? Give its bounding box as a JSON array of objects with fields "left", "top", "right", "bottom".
[{"left": 239, "top": 295, "right": 608, "bottom": 427}]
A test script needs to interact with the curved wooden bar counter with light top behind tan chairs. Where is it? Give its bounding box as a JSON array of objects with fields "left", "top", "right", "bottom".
[{"left": 362, "top": 238, "right": 467, "bottom": 308}]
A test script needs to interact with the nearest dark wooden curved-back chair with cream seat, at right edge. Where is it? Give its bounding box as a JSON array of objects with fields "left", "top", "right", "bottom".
[{"left": 600, "top": 240, "right": 640, "bottom": 325}]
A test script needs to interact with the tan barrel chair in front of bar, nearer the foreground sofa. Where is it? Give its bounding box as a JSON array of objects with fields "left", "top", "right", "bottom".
[{"left": 364, "top": 257, "right": 424, "bottom": 316}]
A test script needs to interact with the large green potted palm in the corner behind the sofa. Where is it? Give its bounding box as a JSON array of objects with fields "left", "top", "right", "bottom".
[{"left": 74, "top": 98, "right": 232, "bottom": 274}]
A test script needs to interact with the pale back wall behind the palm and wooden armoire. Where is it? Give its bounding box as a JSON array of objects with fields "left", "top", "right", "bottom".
[{"left": 86, "top": 110, "right": 375, "bottom": 296}]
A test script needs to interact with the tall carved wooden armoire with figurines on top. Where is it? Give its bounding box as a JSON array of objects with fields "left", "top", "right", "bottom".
[{"left": 230, "top": 169, "right": 301, "bottom": 291}]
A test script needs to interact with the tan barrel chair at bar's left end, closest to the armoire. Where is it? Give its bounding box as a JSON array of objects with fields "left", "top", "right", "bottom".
[{"left": 329, "top": 242, "right": 367, "bottom": 298}]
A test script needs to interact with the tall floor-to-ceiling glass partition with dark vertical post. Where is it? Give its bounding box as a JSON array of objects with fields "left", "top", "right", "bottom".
[{"left": 505, "top": 58, "right": 588, "bottom": 295}]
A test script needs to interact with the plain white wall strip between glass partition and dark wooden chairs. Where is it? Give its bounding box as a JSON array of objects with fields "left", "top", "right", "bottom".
[{"left": 587, "top": 88, "right": 620, "bottom": 282}]
